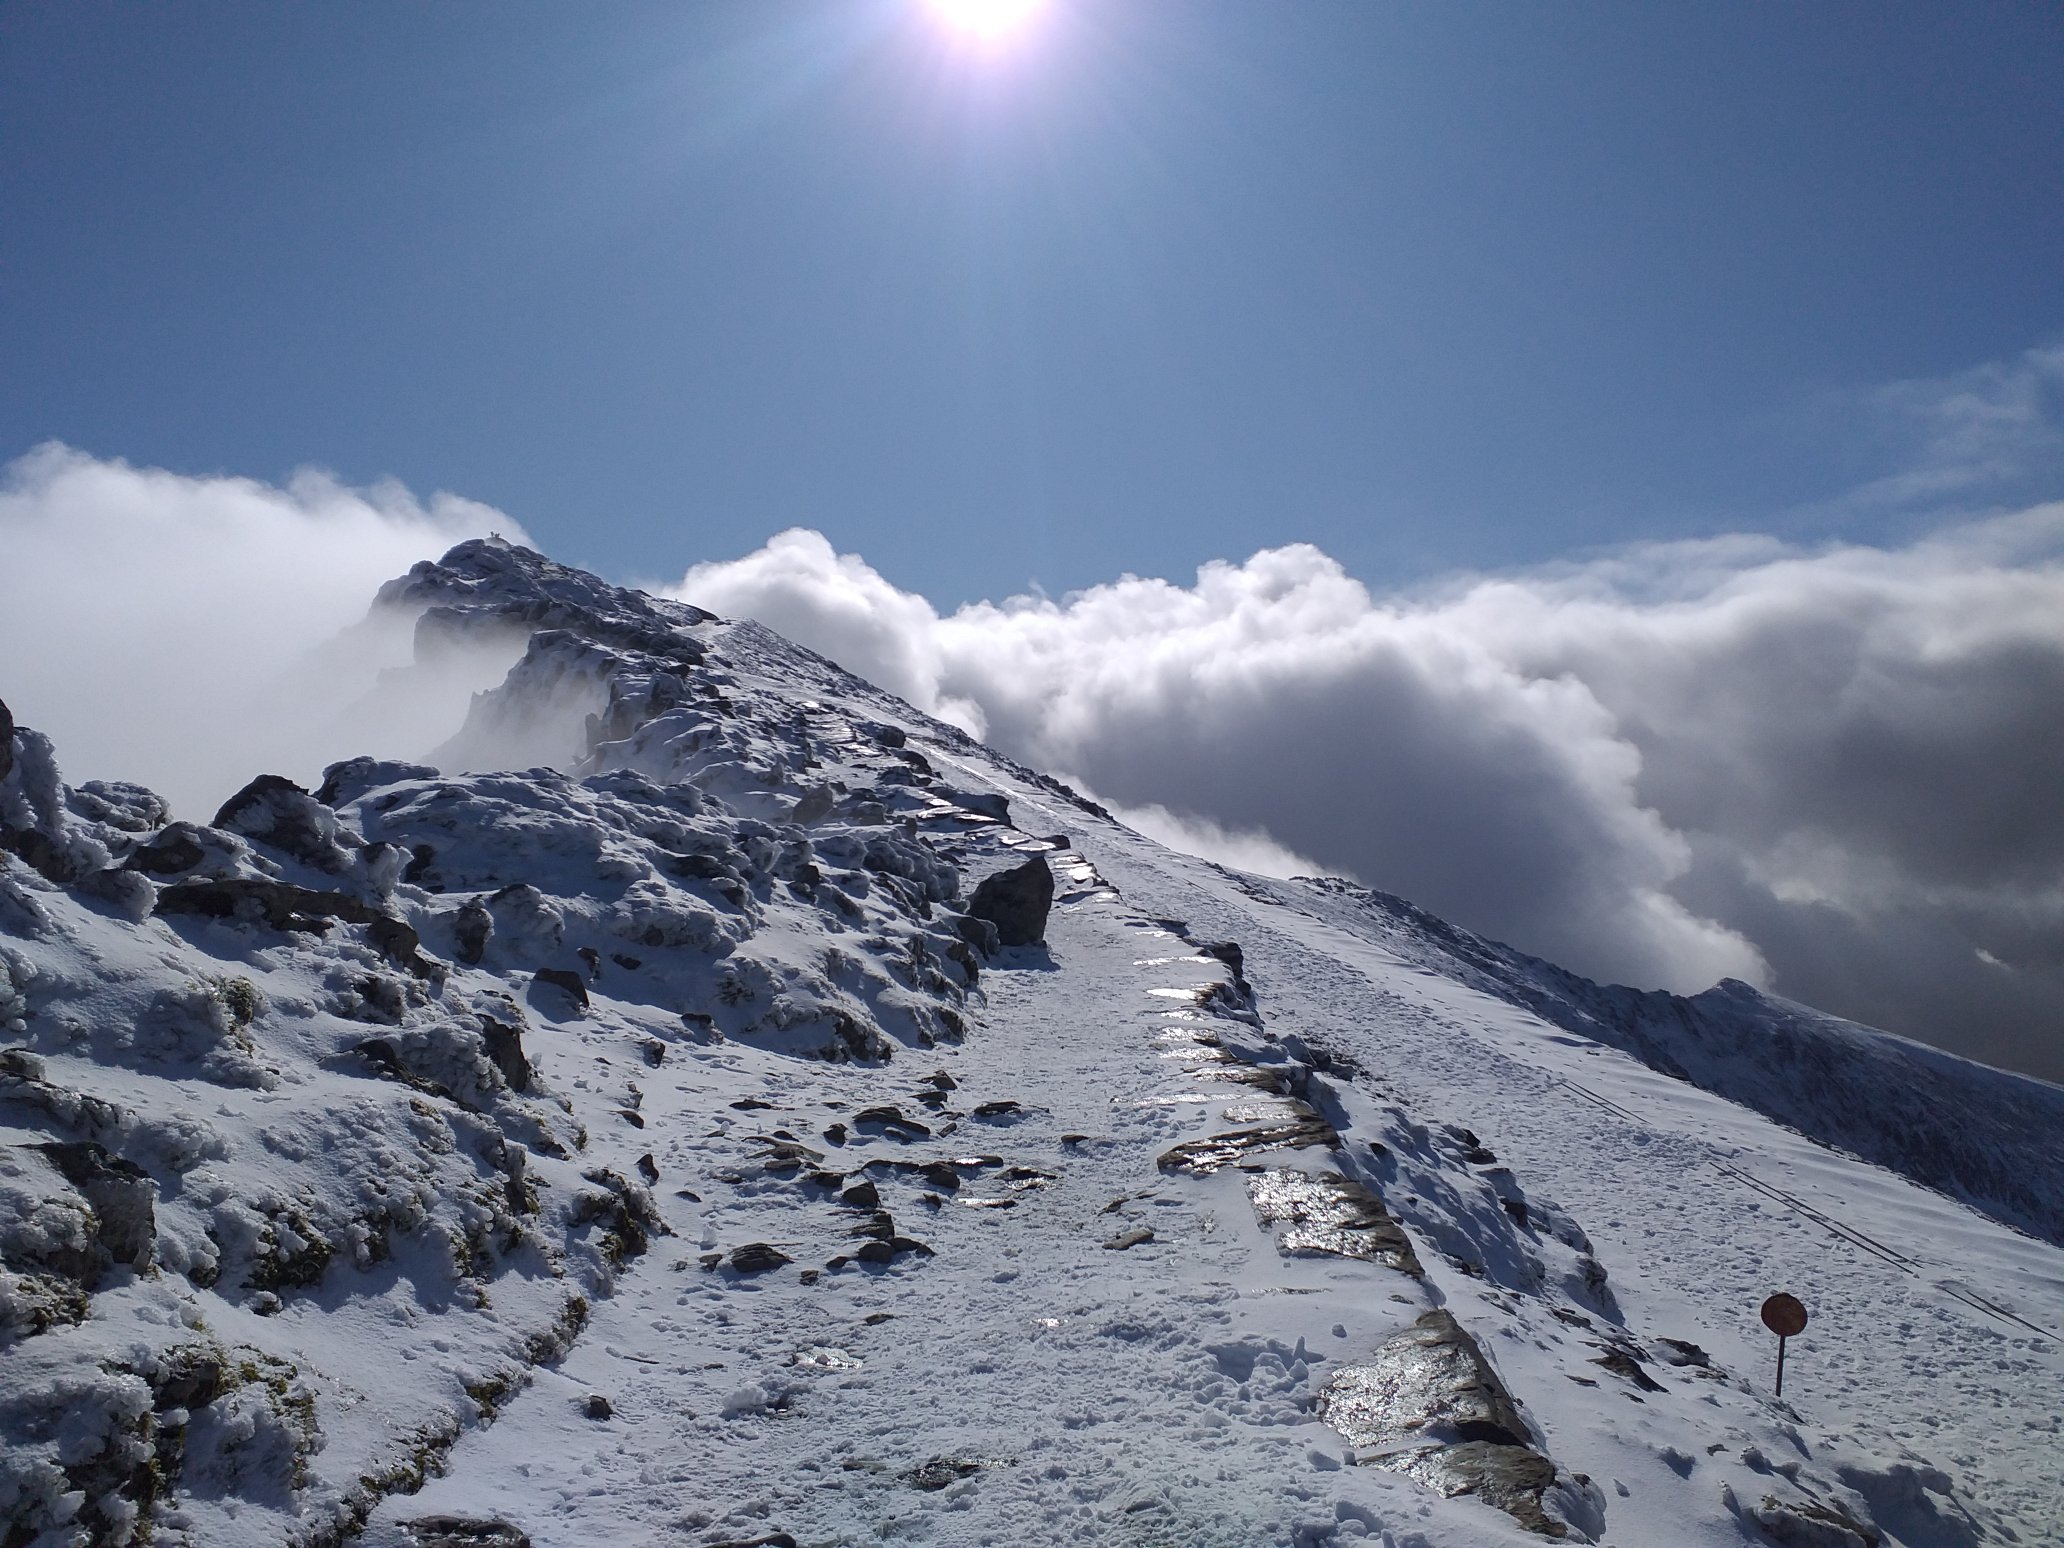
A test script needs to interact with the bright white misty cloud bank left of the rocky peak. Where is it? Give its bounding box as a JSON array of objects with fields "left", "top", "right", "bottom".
[{"left": 0, "top": 444, "right": 522, "bottom": 817}]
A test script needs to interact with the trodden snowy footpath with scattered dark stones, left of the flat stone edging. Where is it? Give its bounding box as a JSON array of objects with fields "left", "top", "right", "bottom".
[{"left": 369, "top": 857, "right": 1529, "bottom": 1548}]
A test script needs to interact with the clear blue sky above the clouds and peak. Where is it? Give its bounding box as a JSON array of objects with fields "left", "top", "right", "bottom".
[{"left": 0, "top": 0, "right": 2064, "bottom": 605}]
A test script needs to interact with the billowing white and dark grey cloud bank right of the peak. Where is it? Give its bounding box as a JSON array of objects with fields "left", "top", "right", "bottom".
[{"left": 677, "top": 522, "right": 2064, "bottom": 1077}]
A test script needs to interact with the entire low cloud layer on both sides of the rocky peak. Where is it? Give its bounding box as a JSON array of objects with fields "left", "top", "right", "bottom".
[{"left": 0, "top": 446, "right": 2064, "bottom": 1079}]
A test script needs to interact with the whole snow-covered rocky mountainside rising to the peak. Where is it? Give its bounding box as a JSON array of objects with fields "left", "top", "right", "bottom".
[{"left": 0, "top": 543, "right": 2064, "bottom": 1548}]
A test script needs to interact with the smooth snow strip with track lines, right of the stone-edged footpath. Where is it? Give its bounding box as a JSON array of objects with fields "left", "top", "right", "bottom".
[{"left": 1104, "top": 804, "right": 2064, "bottom": 1544}]
